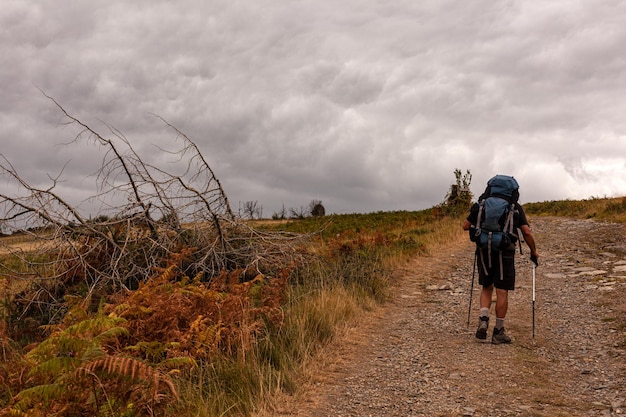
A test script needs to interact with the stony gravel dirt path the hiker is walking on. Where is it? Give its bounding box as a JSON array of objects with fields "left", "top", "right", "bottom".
[{"left": 274, "top": 218, "right": 626, "bottom": 417}]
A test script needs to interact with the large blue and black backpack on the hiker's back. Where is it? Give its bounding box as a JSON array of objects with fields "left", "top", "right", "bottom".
[{"left": 472, "top": 175, "right": 519, "bottom": 278}]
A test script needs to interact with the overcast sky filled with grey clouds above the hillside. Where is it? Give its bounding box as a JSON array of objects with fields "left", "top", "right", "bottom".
[{"left": 0, "top": 0, "right": 626, "bottom": 217}]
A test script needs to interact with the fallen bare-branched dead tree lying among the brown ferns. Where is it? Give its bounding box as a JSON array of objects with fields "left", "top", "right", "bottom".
[{"left": 0, "top": 94, "right": 303, "bottom": 323}]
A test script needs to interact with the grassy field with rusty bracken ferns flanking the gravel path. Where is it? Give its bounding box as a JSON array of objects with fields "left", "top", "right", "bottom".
[{"left": 0, "top": 199, "right": 626, "bottom": 416}]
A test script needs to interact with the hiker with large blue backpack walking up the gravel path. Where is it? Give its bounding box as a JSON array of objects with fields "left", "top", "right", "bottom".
[{"left": 463, "top": 175, "right": 539, "bottom": 344}]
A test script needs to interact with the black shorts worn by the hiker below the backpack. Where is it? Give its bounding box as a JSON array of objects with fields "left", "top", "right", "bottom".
[{"left": 477, "top": 250, "right": 515, "bottom": 291}]
